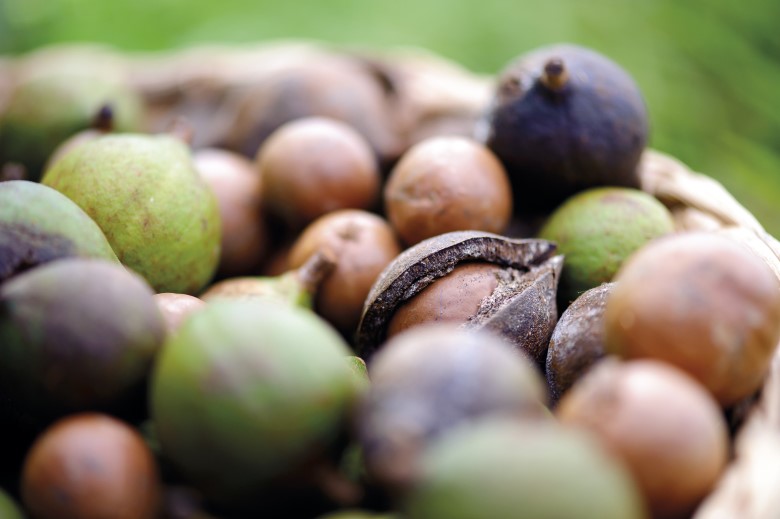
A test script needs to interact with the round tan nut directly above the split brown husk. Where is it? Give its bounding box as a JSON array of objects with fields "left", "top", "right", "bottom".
[{"left": 384, "top": 136, "right": 512, "bottom": 245}]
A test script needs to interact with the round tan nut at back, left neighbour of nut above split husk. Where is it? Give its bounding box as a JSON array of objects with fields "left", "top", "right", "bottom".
[{"left": 256, "top": 117, "right": 381, "bottom": 233}]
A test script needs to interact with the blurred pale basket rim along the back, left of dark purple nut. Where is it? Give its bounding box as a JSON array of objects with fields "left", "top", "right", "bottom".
[{"left": 114, "top": 40, "right": 492, "bottom": 151}]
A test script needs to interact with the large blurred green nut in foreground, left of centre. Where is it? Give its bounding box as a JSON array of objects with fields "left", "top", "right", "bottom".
[{"left": 151, "top": 300, "right": 359, "bottom": 506}]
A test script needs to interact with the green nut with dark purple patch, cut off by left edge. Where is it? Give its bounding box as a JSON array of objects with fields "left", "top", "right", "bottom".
[{"left": 0, "top": 180, "right": 119, "bottom": 282}]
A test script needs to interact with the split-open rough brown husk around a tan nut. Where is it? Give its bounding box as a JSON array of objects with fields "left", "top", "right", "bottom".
[{"left": 355, "top": 230, "right": 563, "bottom": 365}]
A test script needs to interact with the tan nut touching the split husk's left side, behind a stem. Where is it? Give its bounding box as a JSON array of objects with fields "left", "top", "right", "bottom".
[{"left": 288, "top": 209, "right": 401, "bottom": 336}]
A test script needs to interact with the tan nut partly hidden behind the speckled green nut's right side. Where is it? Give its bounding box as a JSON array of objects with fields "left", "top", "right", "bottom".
[{"left": 193, "top": 148, "right": 269, "bottom": 276}]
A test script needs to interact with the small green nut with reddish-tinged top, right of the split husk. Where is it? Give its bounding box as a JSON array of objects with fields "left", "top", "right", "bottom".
[{"left": 539, "top": 187, "right": 674, "bottom": 310}]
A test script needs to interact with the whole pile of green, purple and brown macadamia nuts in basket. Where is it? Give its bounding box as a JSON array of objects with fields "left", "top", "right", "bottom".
[{"left": 0, "top": 40, "right": 780, "bottom": 519}]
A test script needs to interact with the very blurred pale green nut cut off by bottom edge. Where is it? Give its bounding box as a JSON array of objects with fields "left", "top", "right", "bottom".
[{"left": 402, "top": 420, "right": 647, "bottom": 519}]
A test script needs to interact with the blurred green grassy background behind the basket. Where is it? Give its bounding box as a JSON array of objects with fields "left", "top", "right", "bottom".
[{"left": 0, "top": 0, "right": 780, "bottom": 236}]
